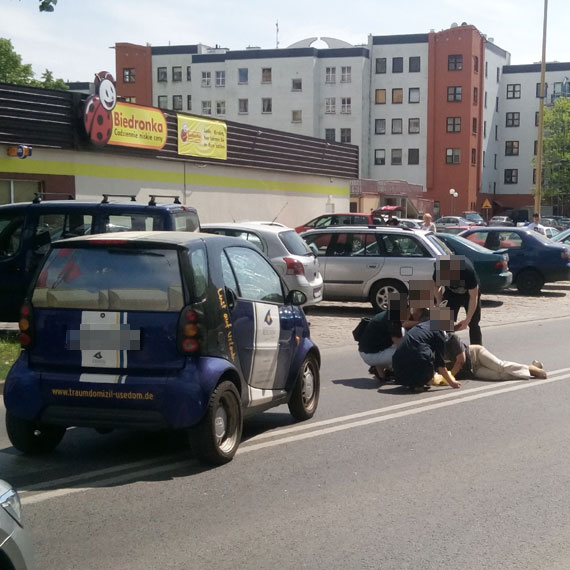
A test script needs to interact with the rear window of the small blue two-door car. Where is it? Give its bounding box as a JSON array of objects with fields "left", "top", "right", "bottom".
[{"left": 32, "top": 247, "right": 184, "bottom": 311}]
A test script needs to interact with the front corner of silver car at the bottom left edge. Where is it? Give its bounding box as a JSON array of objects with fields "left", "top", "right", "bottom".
[{"left": 0, "top": 479, "right": 35, "bottom": 570}]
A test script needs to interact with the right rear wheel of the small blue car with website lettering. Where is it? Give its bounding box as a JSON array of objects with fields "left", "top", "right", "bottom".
[{"left": 190, "top": 381, "right": 243, "bottom": 465}]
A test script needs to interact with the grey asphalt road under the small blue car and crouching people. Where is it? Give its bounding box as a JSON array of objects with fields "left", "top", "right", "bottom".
[{"left": 0, "top": 318, "right": 570, "bottom": 570}]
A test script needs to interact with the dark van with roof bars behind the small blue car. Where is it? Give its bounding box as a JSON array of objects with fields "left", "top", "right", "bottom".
[{"left": 0, "top": 195, "right": 200, "bottom": 321}]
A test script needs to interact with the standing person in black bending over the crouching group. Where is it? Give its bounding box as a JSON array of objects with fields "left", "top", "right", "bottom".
[{"left": 434, "top": 255, "right": 483, "bottom": 344}]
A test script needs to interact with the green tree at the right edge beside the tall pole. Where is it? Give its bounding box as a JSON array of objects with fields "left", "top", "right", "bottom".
[{"left": 542, "top": 97, "right": 570, "bottom": 200}]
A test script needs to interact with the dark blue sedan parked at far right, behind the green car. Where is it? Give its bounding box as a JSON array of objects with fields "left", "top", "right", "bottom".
[{"left": 459, "top": 227, "right": 570, "bottom": 295}]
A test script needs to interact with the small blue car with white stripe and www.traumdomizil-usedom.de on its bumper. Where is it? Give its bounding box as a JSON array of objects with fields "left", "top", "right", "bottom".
[{"left": 4, "top": 232, "right": 320, "bottom": 464}]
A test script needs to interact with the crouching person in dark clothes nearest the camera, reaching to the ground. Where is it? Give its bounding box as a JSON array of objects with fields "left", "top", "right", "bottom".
[{"left": 392, "top": 308, "right": 461, "bottom": 392}]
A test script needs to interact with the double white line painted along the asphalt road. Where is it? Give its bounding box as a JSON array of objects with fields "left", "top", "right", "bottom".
[{"left": 21, "top": 368, "right": 570, "bottom": 505}]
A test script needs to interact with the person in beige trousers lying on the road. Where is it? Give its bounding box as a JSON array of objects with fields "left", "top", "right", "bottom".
[{"left": 445, "top": 333, "right": 547, "bottom": 380}]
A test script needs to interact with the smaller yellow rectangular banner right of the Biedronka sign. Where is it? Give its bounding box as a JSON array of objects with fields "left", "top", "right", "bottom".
[{"left": 177, "top": 115, "right": 228, "bottom": 160}]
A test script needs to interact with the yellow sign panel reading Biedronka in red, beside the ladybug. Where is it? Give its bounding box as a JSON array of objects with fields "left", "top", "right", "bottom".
[{"left": 107, "top": 102, "right": 168, "bottom": 149}]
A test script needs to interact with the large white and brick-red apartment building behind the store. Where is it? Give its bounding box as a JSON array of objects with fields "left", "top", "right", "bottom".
[{"left": 116, "top": 23, "right": 570, "bottom": 214}]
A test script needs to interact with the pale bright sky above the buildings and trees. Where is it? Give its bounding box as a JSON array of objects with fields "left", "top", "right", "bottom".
[{"left": 0, "top": 0, "right": 570, "bottom": 81}]
